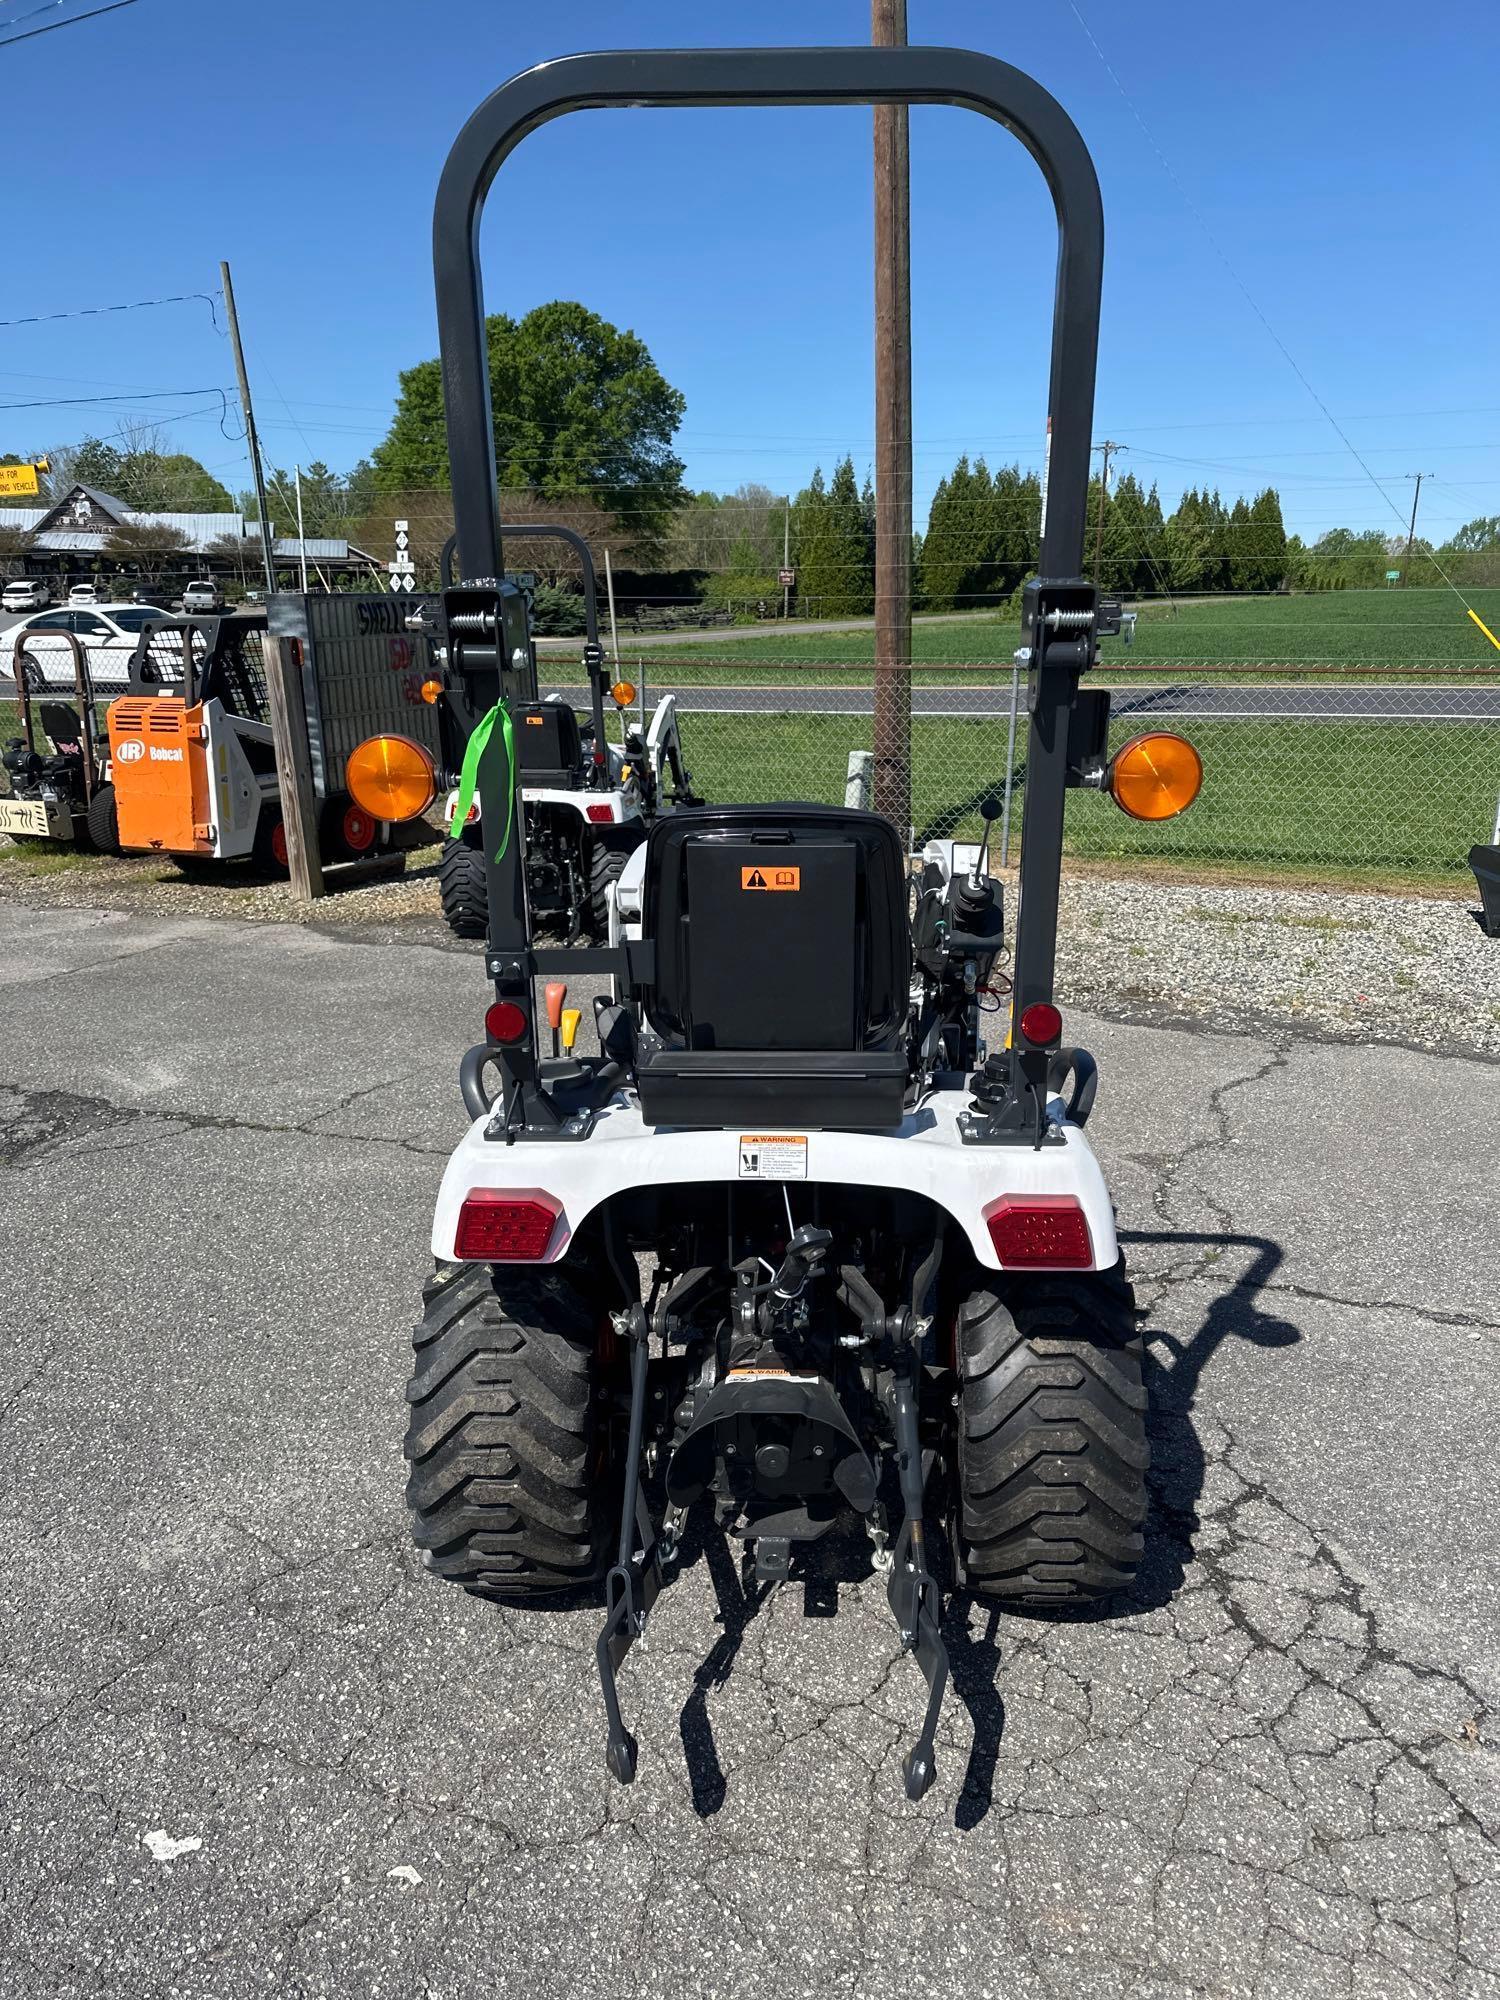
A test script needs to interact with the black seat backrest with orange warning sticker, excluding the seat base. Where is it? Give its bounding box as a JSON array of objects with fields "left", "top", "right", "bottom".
[{"left": 642, "top": 804, "right": 910, "bottom": 1052}]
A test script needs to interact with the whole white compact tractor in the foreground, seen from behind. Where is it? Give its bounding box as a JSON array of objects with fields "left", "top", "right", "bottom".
[{"left": 344, "top": 48, "right": 1202, "bottom": 1798}]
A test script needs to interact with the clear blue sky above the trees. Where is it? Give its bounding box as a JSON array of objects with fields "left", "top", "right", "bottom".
[{"left": 0, "top": 0, "right": 1500, "bottom": 540}]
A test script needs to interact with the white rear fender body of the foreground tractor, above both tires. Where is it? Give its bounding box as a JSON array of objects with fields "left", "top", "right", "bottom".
[{"left": 432, "top": 1090, "right": 1120, "bottom": 1270}]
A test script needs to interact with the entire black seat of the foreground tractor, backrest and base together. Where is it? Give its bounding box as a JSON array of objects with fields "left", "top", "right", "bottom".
[{"left": 636, "top": 804, "right": 910, "bottom": 1132}]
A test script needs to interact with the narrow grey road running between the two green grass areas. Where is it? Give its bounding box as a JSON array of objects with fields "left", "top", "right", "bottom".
[{"left": 544, "top": 680, "right": 1500, "bottom": 722}]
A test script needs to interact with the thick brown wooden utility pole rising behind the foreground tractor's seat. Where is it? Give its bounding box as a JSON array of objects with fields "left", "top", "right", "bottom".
[{"left": 870, "top": 0, "right": 912, "bottom": 840}]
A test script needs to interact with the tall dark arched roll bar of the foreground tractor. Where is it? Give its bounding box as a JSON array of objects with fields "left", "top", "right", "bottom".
[{"left": 432, "top": 48, "right": 1104, "bottom": 1126}]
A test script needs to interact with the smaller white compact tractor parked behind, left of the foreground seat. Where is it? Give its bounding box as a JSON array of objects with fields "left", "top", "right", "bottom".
[{"left": 424, "top": 522, "right": 700, "bottom": 944}]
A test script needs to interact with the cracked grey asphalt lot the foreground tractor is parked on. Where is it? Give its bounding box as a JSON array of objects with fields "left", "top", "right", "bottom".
[{"left": 0, "top": 906, "right": 1500, "bottom": 2000}]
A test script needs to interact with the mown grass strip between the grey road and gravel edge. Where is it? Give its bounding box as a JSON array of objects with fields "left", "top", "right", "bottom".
[{"left": 684, "top": 716, "right": 1500, "bottom": 882}]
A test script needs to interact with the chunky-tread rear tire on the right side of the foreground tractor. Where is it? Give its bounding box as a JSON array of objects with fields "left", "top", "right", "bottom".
[{"left": 956, "top": 1264, "right": 1150, "bottom": 1608}]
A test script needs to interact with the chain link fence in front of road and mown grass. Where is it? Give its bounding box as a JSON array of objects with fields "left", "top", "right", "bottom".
[{"left": 554, "top": 650, "right": 1500, "bottom": 886}]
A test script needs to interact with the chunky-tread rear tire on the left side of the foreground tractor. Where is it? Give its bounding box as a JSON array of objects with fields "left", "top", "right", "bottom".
[{"left": 406, "top": 1264, "right": 618, "bottom": 1598}]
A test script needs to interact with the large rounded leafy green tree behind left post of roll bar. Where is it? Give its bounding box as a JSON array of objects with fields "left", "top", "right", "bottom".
[{"left": 372, "top": 300, "right": 686, "bottom": 560}]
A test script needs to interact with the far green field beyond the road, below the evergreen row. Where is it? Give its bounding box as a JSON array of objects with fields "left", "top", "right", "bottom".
[{"left": 620, "top": 590, "right": 1500, "bottom": 684}]
